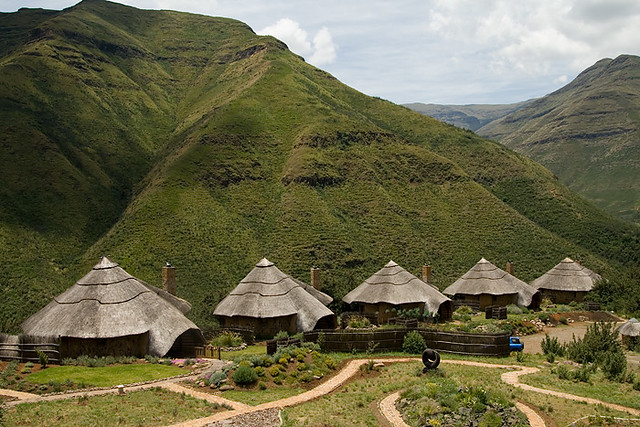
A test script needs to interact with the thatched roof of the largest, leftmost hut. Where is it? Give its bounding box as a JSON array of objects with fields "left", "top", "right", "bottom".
[{"left": 22, "top": 257, "right": 199, "bottom": 356}]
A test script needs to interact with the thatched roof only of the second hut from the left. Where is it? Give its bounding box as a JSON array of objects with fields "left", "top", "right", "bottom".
[{"left": 213, "top": 258, "right": 335, "bottom": 332}]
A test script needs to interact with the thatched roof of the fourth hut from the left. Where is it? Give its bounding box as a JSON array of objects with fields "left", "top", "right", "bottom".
[{"left": 443, "top": 258, "right": 538, "bottom": 307}]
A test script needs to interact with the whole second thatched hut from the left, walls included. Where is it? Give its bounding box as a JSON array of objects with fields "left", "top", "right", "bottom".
[{"left": 213, "top": 258, "right": 336, "bottom": 336}]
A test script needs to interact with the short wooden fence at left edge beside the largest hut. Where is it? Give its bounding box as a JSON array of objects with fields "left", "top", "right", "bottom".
[{"left": 0, "top": 333, "right": 61, "bottom": 363}]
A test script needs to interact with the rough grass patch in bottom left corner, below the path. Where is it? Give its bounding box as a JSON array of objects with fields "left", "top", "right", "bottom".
[{"left": 2, "top": 387, "right": 224, "bottom": 427}]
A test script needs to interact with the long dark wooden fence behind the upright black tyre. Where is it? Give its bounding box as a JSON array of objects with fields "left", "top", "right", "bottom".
[{"left": 304, "top": 328, "right": 509, "bottom": 356}]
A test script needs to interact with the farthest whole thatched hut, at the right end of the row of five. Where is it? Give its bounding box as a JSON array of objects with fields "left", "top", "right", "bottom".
[{"left": 531, "top": 257, "right": 601, "bottom": 303}]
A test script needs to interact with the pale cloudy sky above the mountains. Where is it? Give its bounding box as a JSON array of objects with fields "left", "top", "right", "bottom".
[{"left": 0, "top": 0, "right": 640, "bottom": 104}]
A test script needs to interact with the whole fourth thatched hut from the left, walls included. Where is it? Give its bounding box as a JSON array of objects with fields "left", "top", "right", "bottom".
[{"left": 443, "top": 258, "right": 540, "bottom": 309}]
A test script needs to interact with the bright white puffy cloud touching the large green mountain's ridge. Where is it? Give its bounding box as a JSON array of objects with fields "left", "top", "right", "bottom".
[{"left": 258, "top": 18, "right": 337, "bottom": 66}]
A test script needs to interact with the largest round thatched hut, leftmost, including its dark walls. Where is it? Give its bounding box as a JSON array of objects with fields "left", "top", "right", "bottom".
[{"left": 22, "top": 257, "right": 204, "bottom": 357}]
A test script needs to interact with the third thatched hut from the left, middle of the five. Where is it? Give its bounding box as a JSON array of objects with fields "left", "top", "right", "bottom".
[{"left": 342, "top": 261, "right": 452, "bottom": 322}]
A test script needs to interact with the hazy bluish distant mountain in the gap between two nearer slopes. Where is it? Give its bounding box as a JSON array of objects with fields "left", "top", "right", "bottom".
[{"left": 403, "top": 101, "right": 531, "bottom": 131}]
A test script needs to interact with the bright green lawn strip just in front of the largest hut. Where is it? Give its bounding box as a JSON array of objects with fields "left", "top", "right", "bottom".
[{"left": 25, "top": 363, "right": 188, "bottom": 387}]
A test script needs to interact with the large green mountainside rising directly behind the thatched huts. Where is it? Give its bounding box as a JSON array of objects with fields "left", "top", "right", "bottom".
[{"left": 0, "top": 0, "right": 640, "bottom": 330}]
